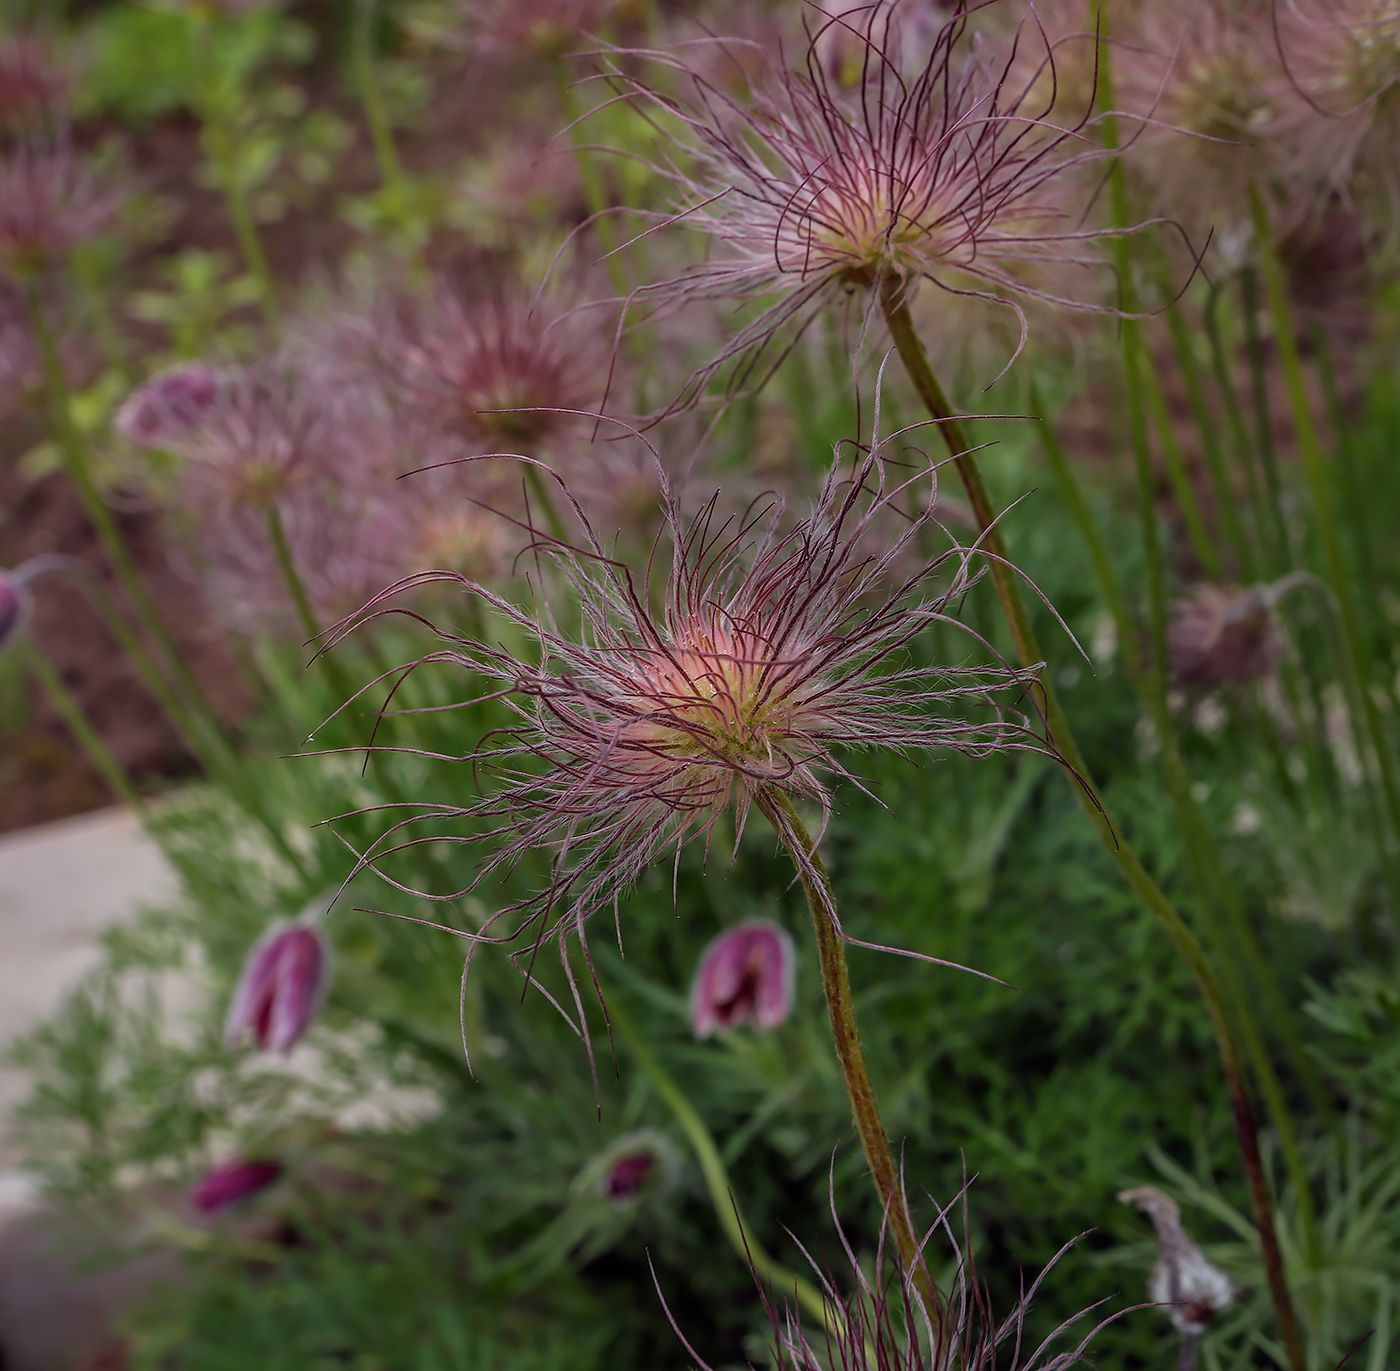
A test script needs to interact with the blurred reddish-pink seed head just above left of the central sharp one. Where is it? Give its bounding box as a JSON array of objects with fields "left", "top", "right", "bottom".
[{"left": 371, "top": 280, "right": 608, "bottom": 447}]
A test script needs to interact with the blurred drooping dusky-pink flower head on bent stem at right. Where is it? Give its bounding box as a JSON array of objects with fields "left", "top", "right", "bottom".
[{"left": 1166, "top": 585, "right": 1284, "bottom": 690}]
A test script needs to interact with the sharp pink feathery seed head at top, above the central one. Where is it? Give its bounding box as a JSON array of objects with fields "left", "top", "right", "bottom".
[{"left": 613, "top": 0, "right": 1148, "bottom": 399}]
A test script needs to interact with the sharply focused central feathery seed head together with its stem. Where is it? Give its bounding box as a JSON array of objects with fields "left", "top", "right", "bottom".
[{"left": 333, "top": 425, "right": 1046, "bottom": 1302}]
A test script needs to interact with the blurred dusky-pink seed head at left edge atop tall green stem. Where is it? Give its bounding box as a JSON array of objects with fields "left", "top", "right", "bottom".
[{"left": 0, "top": 139, "right": 122, "bottom": 280}]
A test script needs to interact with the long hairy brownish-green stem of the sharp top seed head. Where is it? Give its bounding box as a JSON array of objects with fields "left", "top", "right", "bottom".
[{"left": 881, "top": 281, "right": 1305, "bottom": 1371}]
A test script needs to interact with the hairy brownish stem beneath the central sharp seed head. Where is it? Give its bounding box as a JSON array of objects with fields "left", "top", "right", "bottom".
[{"left": 756, "top": 786, "right": 942, "bottom": 1328}]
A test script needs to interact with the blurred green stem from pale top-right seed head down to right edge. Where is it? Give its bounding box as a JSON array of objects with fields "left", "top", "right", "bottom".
[{"left": 1250, "top": 186, "right": 1400, "bottom": 856}]
